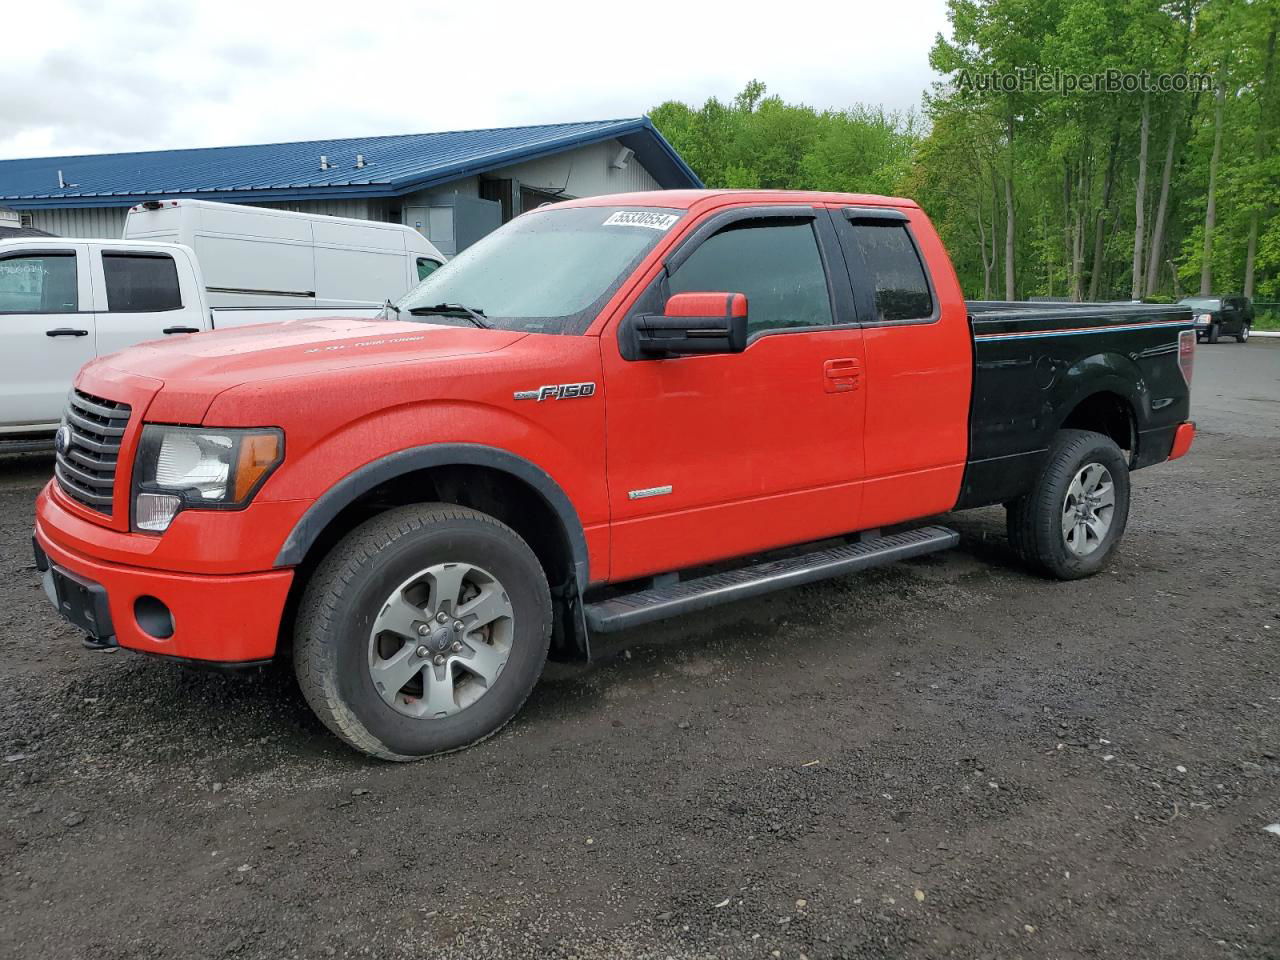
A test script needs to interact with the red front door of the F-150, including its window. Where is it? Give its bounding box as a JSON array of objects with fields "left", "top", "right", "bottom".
[{"left": 602, "top": 207, "right": 865, "bottom": 581}]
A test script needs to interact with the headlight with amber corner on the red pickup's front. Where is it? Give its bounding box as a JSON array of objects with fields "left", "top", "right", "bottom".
[{"left": 133, "top": 424, "right": 284, "bottom": 534}]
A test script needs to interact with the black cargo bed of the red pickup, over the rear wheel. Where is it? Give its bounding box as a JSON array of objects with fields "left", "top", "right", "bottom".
[{"left": 957, "top": 301, "right": 1192, "bottom": 507}]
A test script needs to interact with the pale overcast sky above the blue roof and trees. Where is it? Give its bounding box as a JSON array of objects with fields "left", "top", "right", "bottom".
[{"left": 0, "top": 0, "right": 947, "bottom": 157}]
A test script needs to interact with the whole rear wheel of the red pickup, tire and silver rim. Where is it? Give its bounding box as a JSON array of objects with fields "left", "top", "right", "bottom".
[{"left": 1006, "top": 430, "right": 1129, "bottom": 580}]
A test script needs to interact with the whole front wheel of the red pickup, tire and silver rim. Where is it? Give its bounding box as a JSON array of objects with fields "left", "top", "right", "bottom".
[{"left": 293, "top": 503, "right": 552, "bottom": 760}]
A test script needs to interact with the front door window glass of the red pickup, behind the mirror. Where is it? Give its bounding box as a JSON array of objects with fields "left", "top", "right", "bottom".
[{"left": 669, "top": 219, "right": 832, "bottom": 334}]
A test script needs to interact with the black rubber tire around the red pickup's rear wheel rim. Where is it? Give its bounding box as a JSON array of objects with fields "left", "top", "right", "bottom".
[{"left": 1006, "top": 430, "right": 1129, "bottom": 580}]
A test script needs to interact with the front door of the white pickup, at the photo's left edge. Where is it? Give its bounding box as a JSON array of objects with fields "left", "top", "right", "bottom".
[{"left": 0, "top": 243, "right": 95, "bottom": 428}]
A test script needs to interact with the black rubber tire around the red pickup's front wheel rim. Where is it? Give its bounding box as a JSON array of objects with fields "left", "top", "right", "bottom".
[{"left": 293, "top": 503, "right": 552, "bottom": 760}]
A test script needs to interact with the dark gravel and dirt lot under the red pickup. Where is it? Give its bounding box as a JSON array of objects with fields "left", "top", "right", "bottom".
[{"left": 0, "top": 340, "right": 1280, "bottom": 960}]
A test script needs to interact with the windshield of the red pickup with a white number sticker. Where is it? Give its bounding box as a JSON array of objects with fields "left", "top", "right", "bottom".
[{"left": 396, "top": 206, "right": 685, "bottom": 334}]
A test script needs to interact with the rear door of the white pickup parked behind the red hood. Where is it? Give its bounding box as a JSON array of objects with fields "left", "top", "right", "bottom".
[{"left": 92, "top": 246, "right": 207, "bottom": 356}]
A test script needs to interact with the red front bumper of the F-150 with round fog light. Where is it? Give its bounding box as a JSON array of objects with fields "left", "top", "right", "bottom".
[{"left": 35, "top": 512, "right": 293, "bottom": 663}]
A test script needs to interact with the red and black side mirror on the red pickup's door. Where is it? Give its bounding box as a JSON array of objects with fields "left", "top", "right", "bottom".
[{"left": 622, "top": 293, "right": 746, "bottom": 360}]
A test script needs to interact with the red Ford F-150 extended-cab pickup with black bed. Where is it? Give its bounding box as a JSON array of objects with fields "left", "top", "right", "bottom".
[{"left": 35, "top": 191, "right": 1196, "bottom": 760}]
